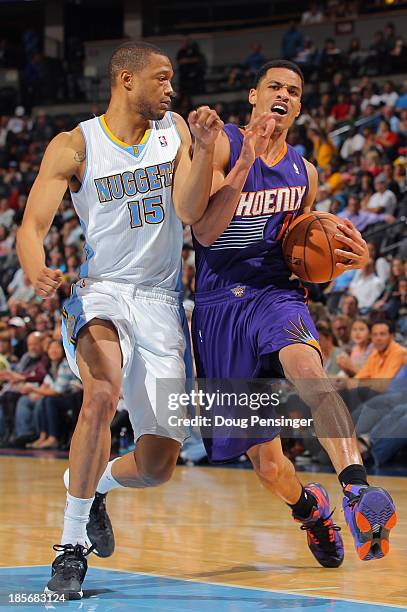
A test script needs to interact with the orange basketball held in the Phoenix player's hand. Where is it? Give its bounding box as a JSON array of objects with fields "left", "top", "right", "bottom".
[{"left": 283, "top": 212, "right": 346, "bottom": 283}]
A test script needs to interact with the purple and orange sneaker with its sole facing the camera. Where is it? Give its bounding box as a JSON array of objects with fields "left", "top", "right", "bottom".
[{"left": 342, "top": 485, "right": 397, "bottom": 561}]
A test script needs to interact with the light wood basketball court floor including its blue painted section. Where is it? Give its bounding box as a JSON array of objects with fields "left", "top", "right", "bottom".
[{"left": 0, "top": 456, "right": 407, "bottom": 612}]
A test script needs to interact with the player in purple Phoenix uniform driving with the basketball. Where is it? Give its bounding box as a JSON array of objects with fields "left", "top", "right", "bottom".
[{"left": 193, "top": 60, "right": 396, "bottom": 567}]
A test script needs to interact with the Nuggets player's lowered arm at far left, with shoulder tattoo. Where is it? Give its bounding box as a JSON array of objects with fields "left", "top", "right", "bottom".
[{"left": 17, "top": 130, "right": 85, "bottom": 297}]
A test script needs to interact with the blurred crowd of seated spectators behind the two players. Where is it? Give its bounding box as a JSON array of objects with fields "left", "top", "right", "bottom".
[{"left": 0, "top": 26, "right": 407, "bottom": 464}]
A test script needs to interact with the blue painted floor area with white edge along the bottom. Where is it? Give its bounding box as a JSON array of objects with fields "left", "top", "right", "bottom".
[{"left": 0, "top": 566, "right": 405, "bottom": 612}]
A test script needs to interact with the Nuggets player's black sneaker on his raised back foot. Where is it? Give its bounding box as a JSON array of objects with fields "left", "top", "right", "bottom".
[{"left": 86, "top": 492, "right": 115, "bottom": 557}]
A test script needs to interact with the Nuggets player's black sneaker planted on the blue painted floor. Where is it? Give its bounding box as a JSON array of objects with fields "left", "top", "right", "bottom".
[{"left": 45, "top": 544, "right": 93, "bottom": 600}]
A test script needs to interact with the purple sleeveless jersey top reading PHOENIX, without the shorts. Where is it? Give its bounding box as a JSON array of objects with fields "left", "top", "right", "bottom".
[{"left": 194, "top": 124, "right": 308, "bottom": 292}]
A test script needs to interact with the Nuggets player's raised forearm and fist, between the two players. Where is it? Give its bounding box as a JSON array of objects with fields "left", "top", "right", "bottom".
[{"left": 173, "top": 106, "right": 223, "bottom": 225}]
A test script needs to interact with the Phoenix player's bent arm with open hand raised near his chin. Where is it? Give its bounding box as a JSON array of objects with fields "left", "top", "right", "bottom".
[{"left": 193, "top": 113, "right": 275, "bottom": 246}]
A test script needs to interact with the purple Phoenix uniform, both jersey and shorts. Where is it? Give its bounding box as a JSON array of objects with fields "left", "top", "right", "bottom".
[{"left": 192, "top": 125, "right": 320, "bottom": 461}]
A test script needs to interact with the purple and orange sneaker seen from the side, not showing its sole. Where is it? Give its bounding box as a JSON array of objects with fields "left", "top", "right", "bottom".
[{"left": 293, "top": 483, "right": 344, "bottom": 567}]
